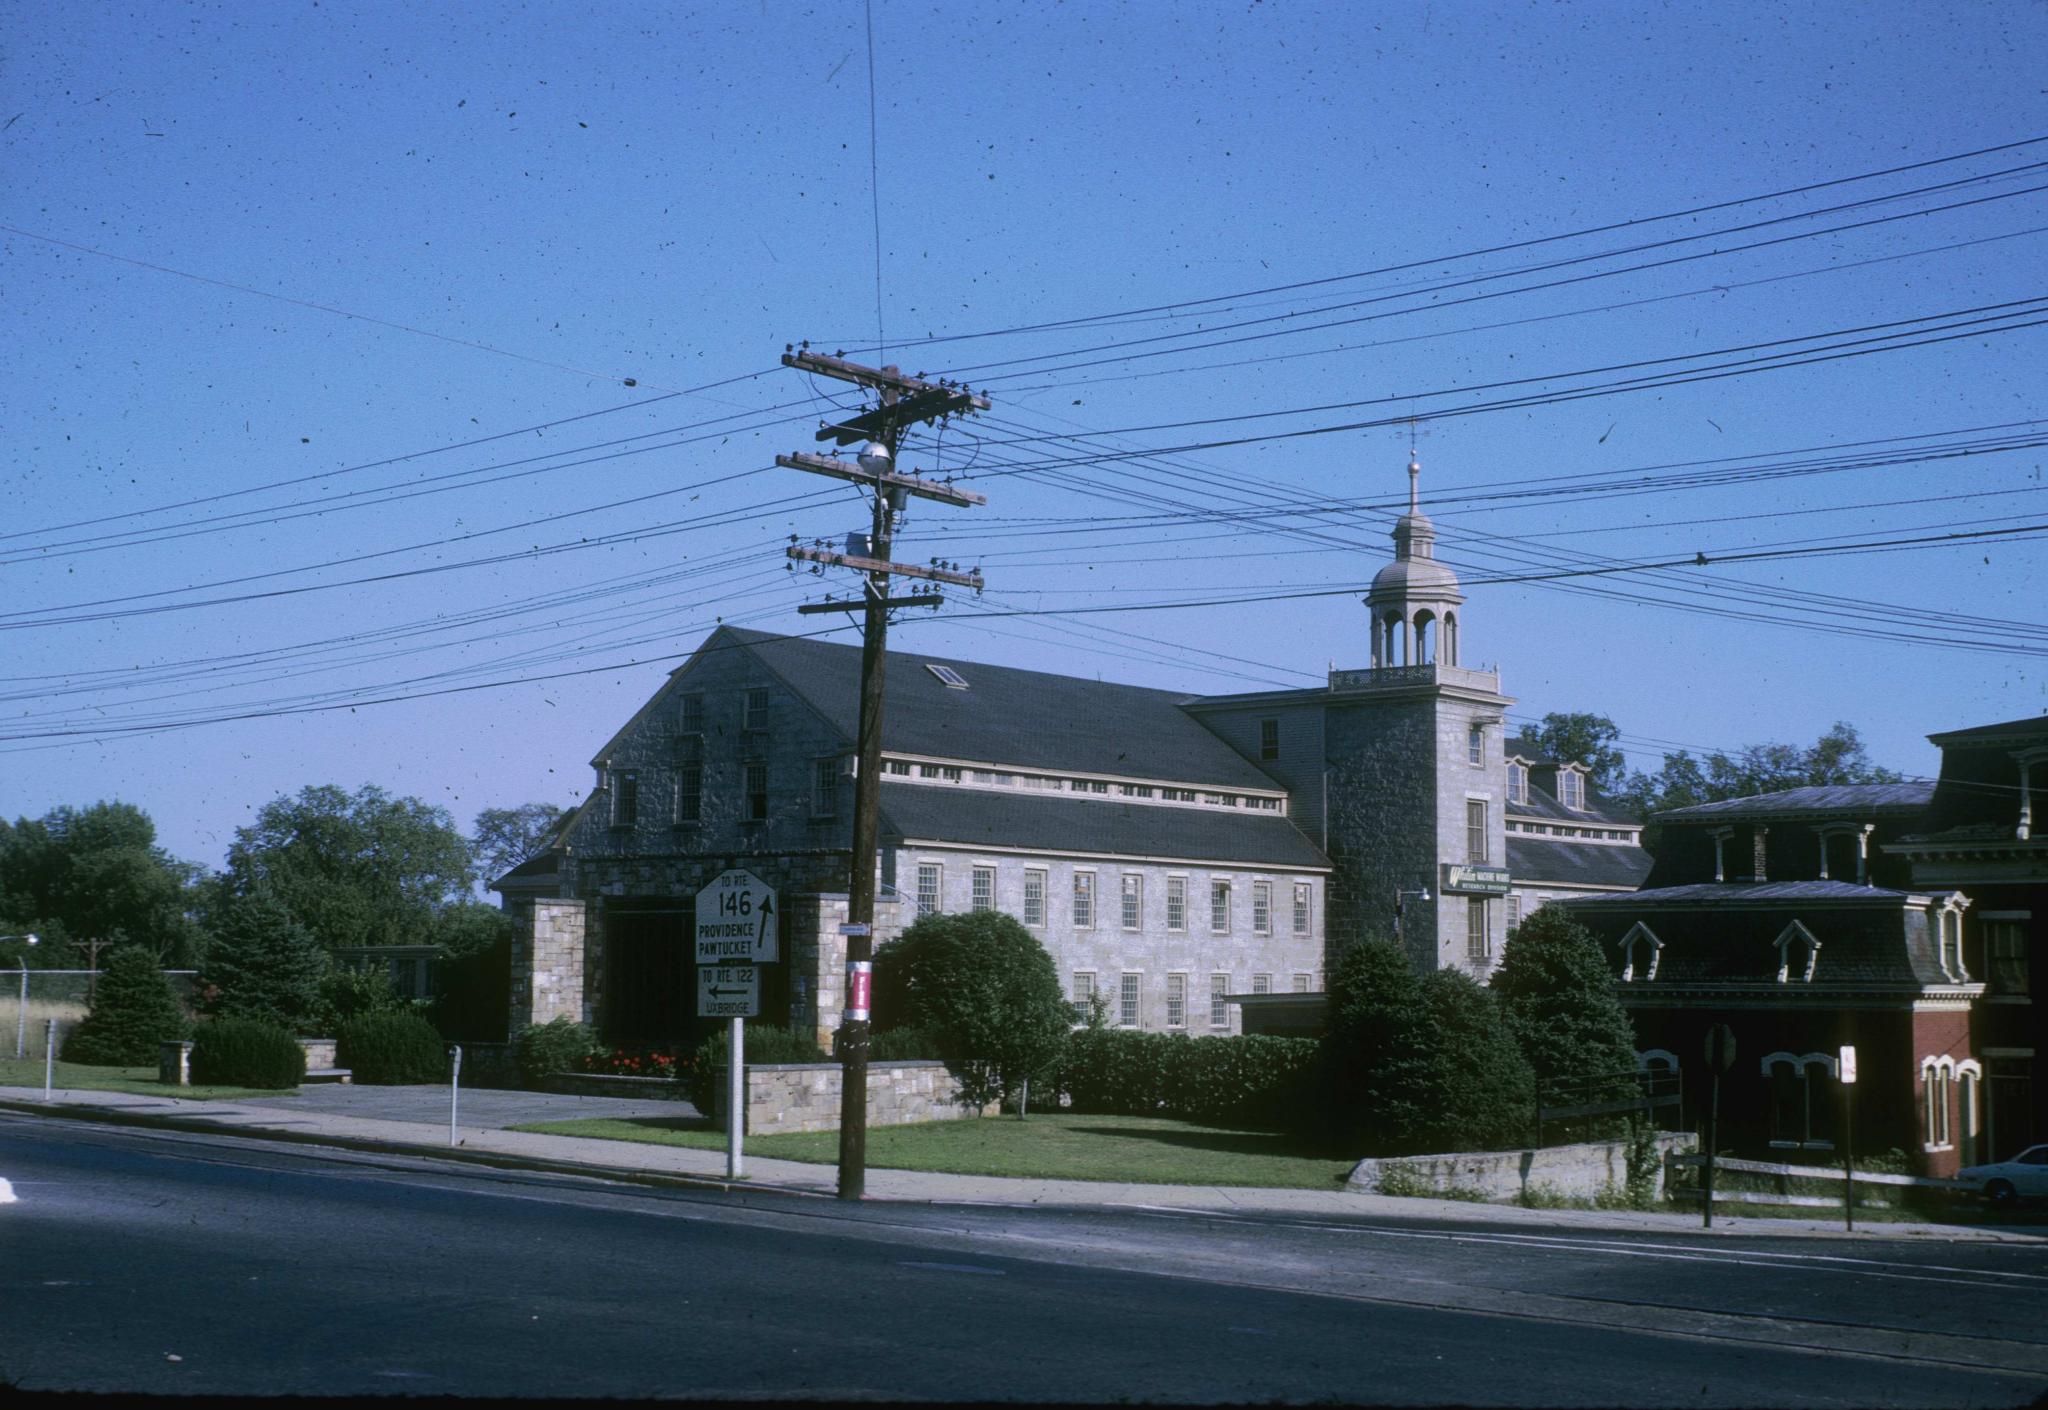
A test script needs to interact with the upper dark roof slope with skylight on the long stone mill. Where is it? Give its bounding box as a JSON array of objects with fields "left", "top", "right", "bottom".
[{"left": 721, "top": 627, "right": 1280, "bottom": 791}]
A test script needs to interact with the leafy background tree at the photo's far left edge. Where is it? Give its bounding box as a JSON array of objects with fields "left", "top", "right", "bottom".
[{"left": 0, "top": 801, "right": 205, "bottom": 967}]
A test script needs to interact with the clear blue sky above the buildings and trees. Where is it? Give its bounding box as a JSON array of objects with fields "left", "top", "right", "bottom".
[{"left": 0, "top": 0, "right": 2048, "bottom": 865}]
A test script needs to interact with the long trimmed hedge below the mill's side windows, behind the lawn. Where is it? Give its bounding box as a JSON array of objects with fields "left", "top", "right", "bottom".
[{"left": 1032, "top": 1029, "right": 1319, "bottom": 1129}]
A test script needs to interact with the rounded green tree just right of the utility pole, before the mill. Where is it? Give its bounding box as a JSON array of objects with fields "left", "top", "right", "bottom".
[{"left": 874, "top": 910, "right": 1073, "bottom": 1107}]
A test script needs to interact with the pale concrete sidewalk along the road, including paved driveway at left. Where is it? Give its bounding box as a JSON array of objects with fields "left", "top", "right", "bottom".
[{"left": 0, "top": 1086, "right": 2048, "bottom": 1242}]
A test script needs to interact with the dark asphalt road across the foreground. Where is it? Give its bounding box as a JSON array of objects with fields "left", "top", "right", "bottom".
[{"left": 0, "top": 1117, "right": 2048, "bottom": 1406}]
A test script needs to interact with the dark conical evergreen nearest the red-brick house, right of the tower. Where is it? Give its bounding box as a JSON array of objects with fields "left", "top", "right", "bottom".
[{"left": 1493, "top": 906, "right": 1636, "bottom": 1080}]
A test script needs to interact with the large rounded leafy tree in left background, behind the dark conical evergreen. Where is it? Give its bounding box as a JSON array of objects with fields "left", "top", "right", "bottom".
[{"left": 227, "top": 783, "right": 475, "bottom": 949}]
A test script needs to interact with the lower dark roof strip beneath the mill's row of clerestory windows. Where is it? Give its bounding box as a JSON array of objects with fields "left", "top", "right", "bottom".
[{"left": 883, "top": 783, "right": 1329, "bottom": 867}]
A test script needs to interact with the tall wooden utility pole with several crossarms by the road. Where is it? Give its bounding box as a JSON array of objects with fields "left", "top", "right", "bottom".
[{"left": 776, "top": 350, "right": 989, "bottom": 1199}]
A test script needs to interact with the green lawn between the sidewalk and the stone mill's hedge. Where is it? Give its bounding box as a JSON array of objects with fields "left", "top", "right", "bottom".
[{"left": 512, "top": 1113, "right": 1352, "bottom": 1189}]
